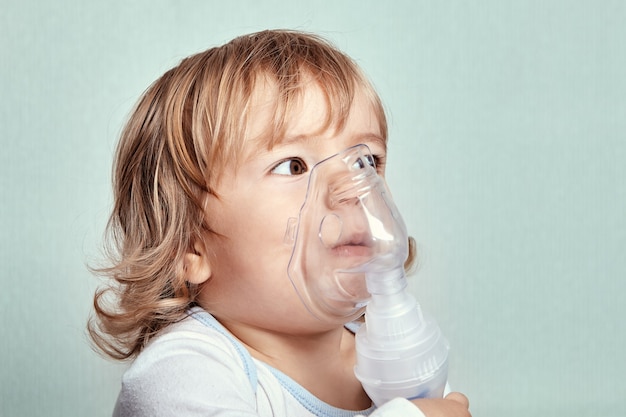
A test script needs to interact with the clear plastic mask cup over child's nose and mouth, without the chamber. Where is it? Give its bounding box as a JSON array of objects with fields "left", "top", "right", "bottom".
[{"left": 286, "top": 145, "right": 408, "bottom": 323}]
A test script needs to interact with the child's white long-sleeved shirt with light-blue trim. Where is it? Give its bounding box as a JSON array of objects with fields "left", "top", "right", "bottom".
[{"left": 113, "top": 307, "right": 424, "bottom": 417}]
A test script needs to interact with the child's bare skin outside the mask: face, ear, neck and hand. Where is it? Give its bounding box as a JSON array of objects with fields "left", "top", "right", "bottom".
[{"left": 185, "top": 79, "right": 468, "bottom": 416}]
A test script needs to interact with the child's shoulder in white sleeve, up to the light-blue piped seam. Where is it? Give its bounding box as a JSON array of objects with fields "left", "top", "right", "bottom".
[{"left": 115, "top": 312, "right": 256, "bottom": 416}]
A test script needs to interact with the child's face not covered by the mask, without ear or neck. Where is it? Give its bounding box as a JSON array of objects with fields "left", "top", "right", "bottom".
[{"left": 198, "top": 79, "right": 386, "bottom": 333}]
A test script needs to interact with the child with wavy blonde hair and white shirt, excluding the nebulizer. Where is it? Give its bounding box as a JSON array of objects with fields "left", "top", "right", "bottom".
[{"left": 89, "top": 31, "right": 469, "bottom": 417}]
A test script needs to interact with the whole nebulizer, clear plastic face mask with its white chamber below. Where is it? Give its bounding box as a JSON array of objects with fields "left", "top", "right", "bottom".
[{"left": 286, "top": 145, "right": 448, "bottom": 405}]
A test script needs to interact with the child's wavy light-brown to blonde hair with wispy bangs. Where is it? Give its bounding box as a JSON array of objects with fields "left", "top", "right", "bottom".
[{"left": 88, "top": 30, "right": 413, "bottom": 359}]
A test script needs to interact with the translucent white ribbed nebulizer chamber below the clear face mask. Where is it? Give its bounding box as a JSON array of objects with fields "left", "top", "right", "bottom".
[{"left": 354, "top": 264, "right": 449, "bottom": 406}]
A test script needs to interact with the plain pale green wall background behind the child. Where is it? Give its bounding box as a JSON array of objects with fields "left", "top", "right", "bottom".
[{"left": 0, "top": 0, "right": 626, "bottom": 417}]
